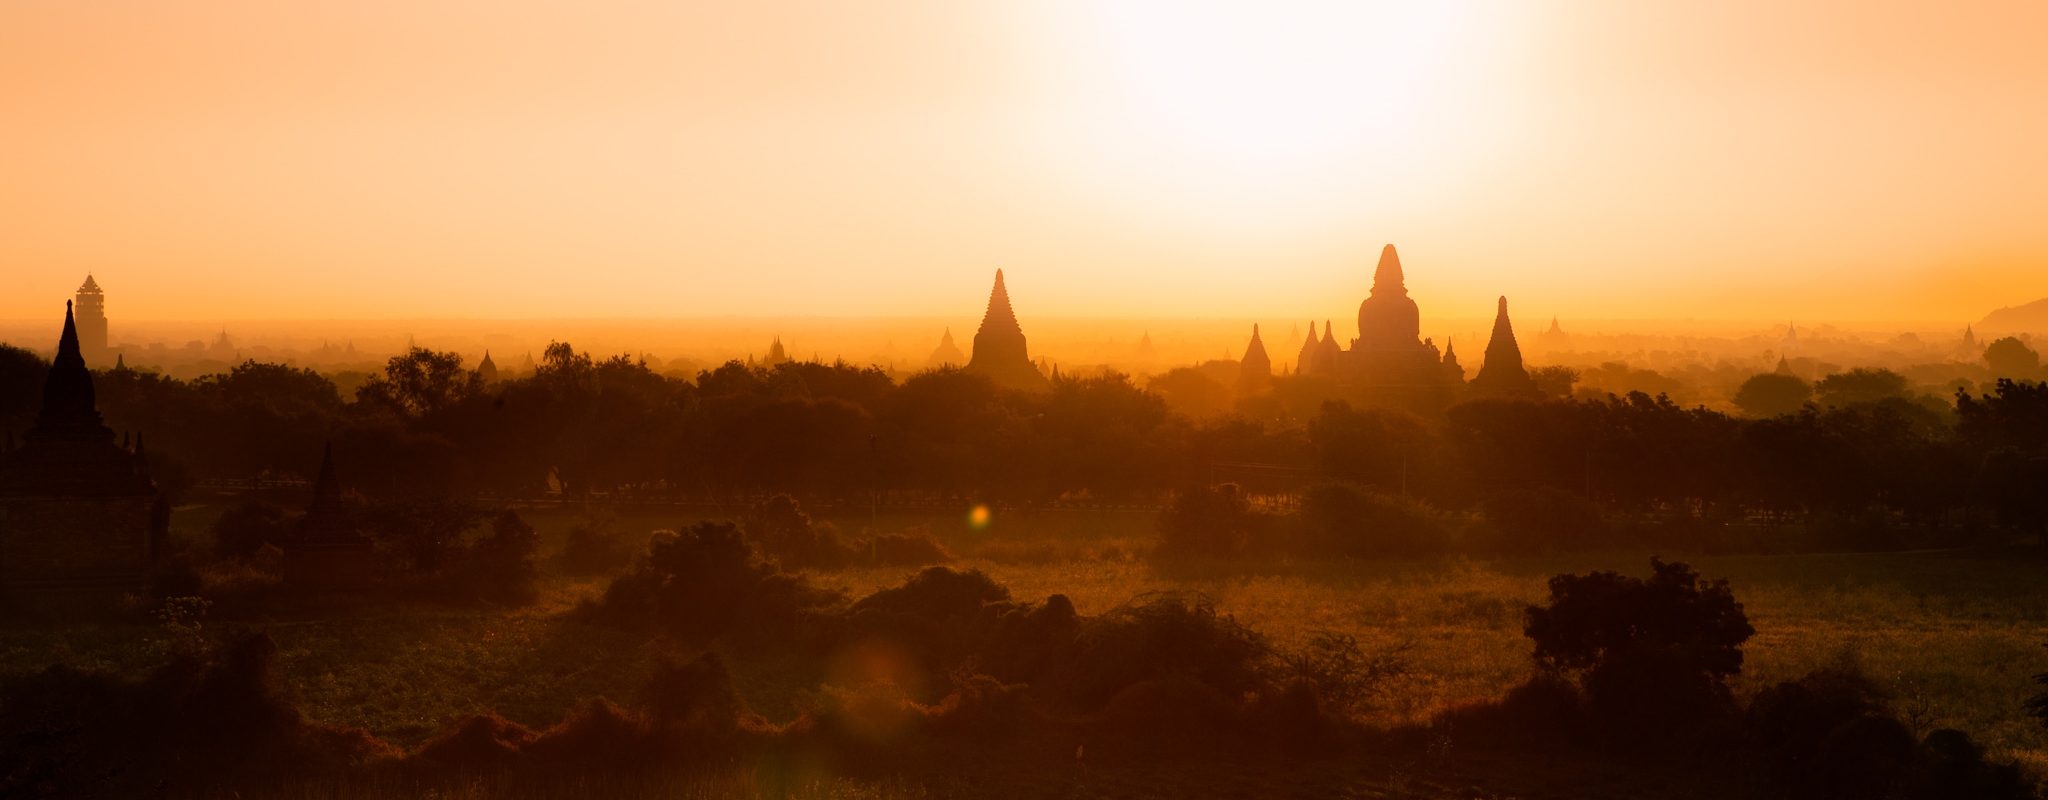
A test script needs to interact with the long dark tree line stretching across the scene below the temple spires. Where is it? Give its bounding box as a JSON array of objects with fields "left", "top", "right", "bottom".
[{"left": 0, "top": 342, "right": 2048, "bottom": 548}]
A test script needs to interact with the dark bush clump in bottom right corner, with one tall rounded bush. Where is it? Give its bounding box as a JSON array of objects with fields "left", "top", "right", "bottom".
[{"left": 1436, "top": 559, "right": 2034, "bottom": 800}]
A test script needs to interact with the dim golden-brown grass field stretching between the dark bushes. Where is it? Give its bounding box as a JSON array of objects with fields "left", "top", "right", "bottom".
[{"left": 0, "top": 507, "right": 2048, "bottom": 785}]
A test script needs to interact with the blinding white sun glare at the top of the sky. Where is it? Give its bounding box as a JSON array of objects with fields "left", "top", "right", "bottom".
[{"left": 1092, "top": 0, "right": 1470, "bottom": 172}]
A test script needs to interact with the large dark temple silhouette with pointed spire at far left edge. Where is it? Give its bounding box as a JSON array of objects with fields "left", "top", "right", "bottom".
[{"left": 0, "top": 300, "right": 170, "bottom": 606}]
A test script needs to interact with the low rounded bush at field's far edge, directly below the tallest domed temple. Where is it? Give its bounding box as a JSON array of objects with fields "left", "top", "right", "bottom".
[{"left": 1300, "top": 483, "right": 1448, "bottom": 559}]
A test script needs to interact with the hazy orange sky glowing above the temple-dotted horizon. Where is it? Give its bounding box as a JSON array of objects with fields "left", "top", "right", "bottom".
[{"left": 0, "top": 0, "right": 2048, "bottom": 329}]
